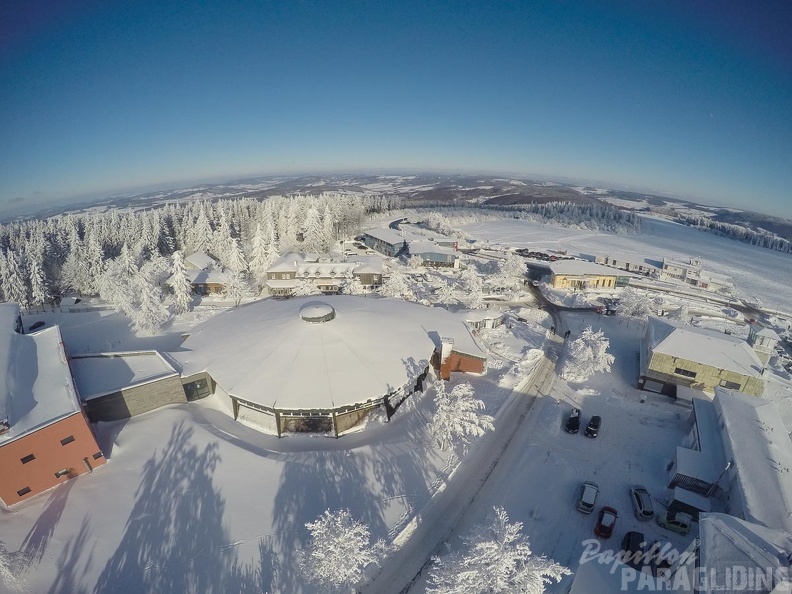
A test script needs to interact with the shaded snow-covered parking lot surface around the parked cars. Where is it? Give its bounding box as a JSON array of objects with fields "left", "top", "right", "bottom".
[{"left": 442, "top": 384, "right": 695, "bottom": 592}]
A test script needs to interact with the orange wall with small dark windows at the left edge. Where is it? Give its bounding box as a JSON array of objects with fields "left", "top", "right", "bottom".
[{"left": 0, "top": 412, "right": 106, "bottom": 505}]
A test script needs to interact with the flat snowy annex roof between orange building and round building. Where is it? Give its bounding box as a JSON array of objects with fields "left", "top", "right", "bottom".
[{"left": 69, "top": 351, "right": 178, "bottom": 400}]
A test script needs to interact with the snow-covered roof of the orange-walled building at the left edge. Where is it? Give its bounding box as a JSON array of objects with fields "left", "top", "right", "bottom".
[{"left": 0, "top": 320, "right": 80, "bottom": 445}]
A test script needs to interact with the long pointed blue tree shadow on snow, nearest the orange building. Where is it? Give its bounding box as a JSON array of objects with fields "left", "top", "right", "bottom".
[{"left": 88, "top": 423, "right": 262, "bottom": 594}]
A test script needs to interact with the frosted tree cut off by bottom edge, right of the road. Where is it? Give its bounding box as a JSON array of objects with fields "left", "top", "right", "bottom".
[{"left": 426, "top": 507, "right": 570, "bottom": 594}]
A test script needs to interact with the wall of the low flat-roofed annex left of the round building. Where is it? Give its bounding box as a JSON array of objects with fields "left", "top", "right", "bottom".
[{"left": 85, "top": 375, "right": 187, "bottom": 421}]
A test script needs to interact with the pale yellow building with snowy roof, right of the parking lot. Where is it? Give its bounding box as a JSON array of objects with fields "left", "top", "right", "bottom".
[{"left": 638, "top": 317, "right": 765, "bottom": 396}]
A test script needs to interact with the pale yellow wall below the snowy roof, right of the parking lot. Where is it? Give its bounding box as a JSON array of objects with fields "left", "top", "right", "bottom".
[{"left": 646, "top": 353, "right": 764, "bottom": 396}]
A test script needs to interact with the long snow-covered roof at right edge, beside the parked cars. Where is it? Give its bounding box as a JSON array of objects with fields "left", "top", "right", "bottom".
[{"left": 714, "top": 388, "right": 792, "bottom": 532}]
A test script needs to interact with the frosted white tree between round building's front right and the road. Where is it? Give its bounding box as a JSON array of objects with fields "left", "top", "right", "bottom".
[{"left": 427, "top": 380, "right": 495, "bottom": 453}]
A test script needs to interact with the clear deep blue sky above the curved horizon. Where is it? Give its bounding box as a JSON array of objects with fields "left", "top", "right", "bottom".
[{"left": 0, "top": 0, "right": 792, "bottom": 217}]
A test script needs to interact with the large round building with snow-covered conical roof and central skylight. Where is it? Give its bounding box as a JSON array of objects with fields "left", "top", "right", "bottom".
[{"left": 171, "top": 295, "right": 486, "bottom": 435}]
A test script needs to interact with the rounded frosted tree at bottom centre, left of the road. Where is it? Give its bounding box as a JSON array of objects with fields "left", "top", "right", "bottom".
[{"left": 298, "top": 509, "right": 387, "bottom": 592}]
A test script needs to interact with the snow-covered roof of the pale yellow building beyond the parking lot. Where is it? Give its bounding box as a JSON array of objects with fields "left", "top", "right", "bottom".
[{"left": 647, "top": 317, "right": 764, "bottom": 377}]
